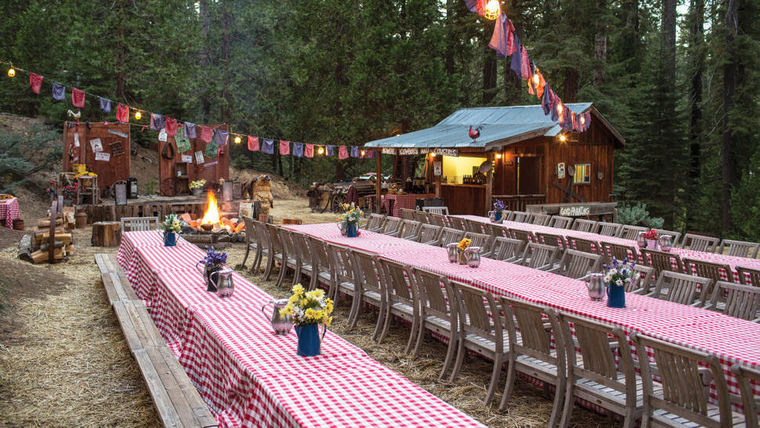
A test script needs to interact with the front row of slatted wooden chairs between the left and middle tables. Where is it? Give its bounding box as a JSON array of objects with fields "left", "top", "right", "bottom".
[{"left": 246, "top": 220, "right": 760, "bottom": 426}]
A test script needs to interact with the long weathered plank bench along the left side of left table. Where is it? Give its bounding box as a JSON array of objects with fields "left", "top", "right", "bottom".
[{"left": 95, "top": 254, "right": 218, "bottom": 428}]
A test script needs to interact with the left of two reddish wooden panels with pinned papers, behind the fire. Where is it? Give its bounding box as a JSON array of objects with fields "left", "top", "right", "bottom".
[{"left": 63, "top": 122, "right": 130, "bottom": 187}]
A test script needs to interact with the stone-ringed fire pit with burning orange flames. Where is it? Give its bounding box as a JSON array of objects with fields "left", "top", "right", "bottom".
[{"left": 180, "top": 190, "right": 245, "bottom": 244}]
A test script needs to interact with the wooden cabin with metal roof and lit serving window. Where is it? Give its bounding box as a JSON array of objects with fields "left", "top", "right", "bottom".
[{"left": 365, "top": 103, "right": 625, "bottom": 215}]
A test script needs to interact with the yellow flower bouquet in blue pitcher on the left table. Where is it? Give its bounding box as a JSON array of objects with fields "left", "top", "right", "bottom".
[{"left": 280, "top": 284, "right": 333, "bottom": 357}]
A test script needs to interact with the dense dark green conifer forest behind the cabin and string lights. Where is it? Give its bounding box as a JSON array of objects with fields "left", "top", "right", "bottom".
[{"left": 0, "top": 0, "right": 760, "bottom": 241}]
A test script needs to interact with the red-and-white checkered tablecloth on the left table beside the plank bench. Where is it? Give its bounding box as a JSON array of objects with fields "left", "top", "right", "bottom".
[{"left": 125, "top": 234, "right": 481, "bottom": 427}]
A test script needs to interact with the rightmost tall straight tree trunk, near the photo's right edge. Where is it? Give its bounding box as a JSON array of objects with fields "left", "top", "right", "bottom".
[{"left": 720, "top": 0, "right": 739, "bottom": 234}]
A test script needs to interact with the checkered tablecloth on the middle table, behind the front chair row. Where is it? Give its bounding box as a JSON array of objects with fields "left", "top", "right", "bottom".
[{"left": 285, "top": 224, "right": 760, "bottom": 404}]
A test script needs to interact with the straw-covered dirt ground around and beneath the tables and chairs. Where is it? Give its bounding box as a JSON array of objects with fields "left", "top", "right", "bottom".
[{"left": 0, "top": 198, "right": 616, "bottom": 428}]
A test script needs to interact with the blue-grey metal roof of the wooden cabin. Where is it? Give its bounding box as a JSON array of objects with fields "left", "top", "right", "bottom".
[{"left": 364, "top": 103, "right": 625, "bottom": 150}]
